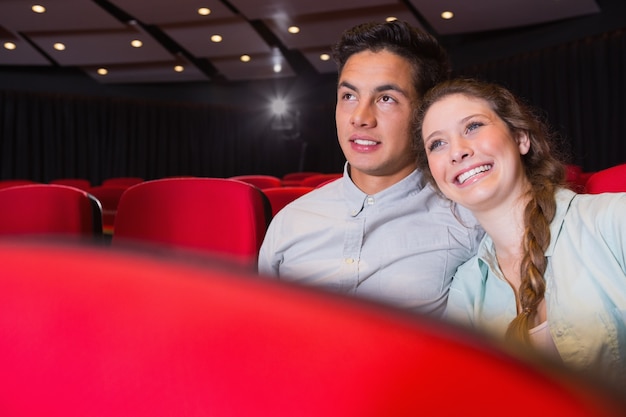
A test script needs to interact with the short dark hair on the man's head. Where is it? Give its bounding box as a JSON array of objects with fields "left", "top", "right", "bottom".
[{"left": 333, "top": 20, "right": 450, "bottom": 98}]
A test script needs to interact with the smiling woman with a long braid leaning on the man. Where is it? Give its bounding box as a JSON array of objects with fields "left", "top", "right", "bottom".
[{"left": 417, "top": 79, "right": 626, "bottom": 381}]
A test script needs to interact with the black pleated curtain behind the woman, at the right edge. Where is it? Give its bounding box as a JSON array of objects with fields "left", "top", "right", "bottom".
[{"left": 457, "top": 26, "right": 626, "bottom": 172}]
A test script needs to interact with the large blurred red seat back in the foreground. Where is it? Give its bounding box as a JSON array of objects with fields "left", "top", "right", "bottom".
[{"left": 0, "top": 241, "right": 625, "bottom": 417}]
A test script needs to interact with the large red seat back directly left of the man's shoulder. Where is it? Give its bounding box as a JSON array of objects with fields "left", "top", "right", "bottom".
[{"left": 112, "top": 178, "right": 271, "bottom": 265}]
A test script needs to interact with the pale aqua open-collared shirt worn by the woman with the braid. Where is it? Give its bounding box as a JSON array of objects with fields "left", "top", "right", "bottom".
[{"left": 447, "top": 189, "right": 626, "bottom": 382}]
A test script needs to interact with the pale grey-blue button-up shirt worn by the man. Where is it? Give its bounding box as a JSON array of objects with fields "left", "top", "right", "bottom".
[{"left": 259, "top": 162, "right": 482, "bottom": 316}]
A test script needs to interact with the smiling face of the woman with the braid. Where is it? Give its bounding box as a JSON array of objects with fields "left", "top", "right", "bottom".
[{"left": 422, "top": 94, "right": 530, "bottom": 211}]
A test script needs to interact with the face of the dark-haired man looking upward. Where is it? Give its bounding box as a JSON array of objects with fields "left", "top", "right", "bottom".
[{"left": 335, "top": 50, "right": 417, "bottom": 186}]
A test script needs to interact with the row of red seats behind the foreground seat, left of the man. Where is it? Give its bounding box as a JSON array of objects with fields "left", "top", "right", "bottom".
[{"left": 0, "top": 177, "right": 311, "bottom": 267}]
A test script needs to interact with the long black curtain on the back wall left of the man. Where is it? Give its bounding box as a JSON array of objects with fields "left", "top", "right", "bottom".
[{"left": 0, "top": 91, "right": 341, "bottom": 184}]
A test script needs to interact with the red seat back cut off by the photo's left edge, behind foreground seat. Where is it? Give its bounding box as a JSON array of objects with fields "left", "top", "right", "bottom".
[{"left": 0, "top": 184, "right": 102, "bottom": 236}]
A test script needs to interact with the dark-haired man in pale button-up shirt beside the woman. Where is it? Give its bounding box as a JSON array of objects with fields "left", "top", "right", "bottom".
[{"left": 259, "top": 21, "right": 481, "bottom": 315}]
